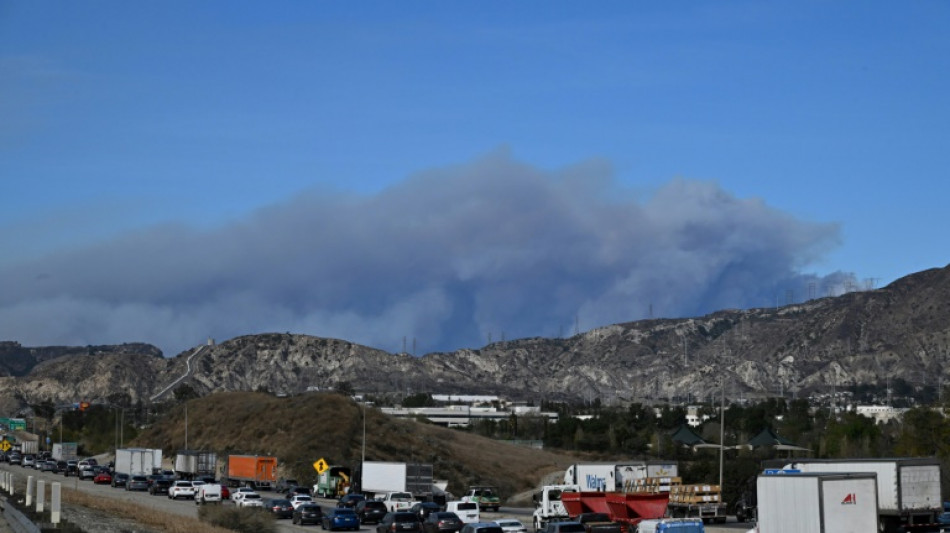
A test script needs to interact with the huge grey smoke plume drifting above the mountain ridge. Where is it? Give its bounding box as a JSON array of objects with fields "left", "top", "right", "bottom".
[{"left": 0, "top": 151, "right": 853, "bottom": 355}]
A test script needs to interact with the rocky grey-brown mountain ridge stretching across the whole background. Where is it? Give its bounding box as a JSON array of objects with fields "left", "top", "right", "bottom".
[{"left": 0, "top": 268, "right": 950, "bottom": 408}]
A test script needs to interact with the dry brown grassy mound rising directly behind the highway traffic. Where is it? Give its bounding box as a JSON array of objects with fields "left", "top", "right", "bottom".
[{"left": 134, "top": 392, "right": 574, "bottom": 496}]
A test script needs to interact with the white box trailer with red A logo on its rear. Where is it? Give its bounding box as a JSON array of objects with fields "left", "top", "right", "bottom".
[{"left": 756, "top": 473, "right": 878, "bottom": 533}]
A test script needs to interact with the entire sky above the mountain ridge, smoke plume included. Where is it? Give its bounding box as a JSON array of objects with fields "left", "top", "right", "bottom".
[{"left": 0, "top": 1, "right": 950, "bottom": 355}]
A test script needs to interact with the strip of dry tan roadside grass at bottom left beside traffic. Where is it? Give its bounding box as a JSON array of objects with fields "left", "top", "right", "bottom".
[{"left": 62, "top": 487, "right": 232, "bottom": 533}]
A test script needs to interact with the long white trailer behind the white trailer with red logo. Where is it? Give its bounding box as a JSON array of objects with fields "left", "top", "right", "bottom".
[{"left": 784, "top": 457, "right": 943, "bottom": 533}]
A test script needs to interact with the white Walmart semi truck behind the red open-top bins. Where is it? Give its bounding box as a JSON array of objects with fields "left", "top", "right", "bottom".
[{"left": 564, "top": 461, "right": 679, "bottom": 492}]
